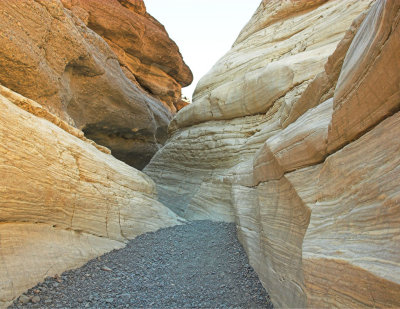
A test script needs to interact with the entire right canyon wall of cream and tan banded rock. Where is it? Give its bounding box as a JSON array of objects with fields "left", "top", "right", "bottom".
[{"left": 144, "top": 0, "right": 400, "bottom": 307}]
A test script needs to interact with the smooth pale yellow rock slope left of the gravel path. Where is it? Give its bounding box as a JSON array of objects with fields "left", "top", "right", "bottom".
[{"left": 0, "top": 86, "right": 179, "bottom": 307}]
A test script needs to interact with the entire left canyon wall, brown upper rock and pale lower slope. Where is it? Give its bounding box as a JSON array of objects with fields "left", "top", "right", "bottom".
[{"left": 0, "top": 0, "right": 188, "bottom": 307}]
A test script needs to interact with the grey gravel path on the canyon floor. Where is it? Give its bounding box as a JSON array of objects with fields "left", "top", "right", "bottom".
[{"left": 11, "top": 221, "right": 272, "bottom": 308}]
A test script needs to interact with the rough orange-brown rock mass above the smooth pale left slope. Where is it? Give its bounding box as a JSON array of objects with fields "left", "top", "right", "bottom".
[{"left": 0, "top": 0, "right": 192, "bottom": 168}]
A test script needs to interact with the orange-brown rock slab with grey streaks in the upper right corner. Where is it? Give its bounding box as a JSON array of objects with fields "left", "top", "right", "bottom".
[{"left": 328, "top": 0, "right": 400, "bottom": 152}]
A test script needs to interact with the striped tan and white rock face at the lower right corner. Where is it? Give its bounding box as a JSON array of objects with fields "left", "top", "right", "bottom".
[{"left": 286, "top": 113, "right": 400, "bottom": 308}]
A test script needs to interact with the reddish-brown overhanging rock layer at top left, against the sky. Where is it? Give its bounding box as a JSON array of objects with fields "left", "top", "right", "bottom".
[{"left": 62, "top": 0, "right": 193, "bottom": 112}]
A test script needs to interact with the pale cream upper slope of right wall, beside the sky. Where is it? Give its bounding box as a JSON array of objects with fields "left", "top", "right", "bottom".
[{"left": 171, "top": 0, "right": 373, "bottom": 128}]
